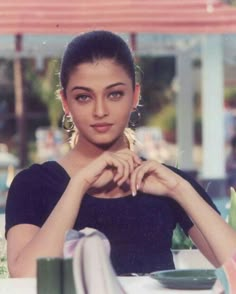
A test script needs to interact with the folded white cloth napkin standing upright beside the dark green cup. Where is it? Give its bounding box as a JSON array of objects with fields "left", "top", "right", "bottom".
[{"left": 64, "top": 228, "right": 125, "bottom": 294}]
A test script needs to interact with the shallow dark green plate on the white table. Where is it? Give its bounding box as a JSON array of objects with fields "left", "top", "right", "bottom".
[{"left": 150, "top": 269, "right": 216, "bottom": 289}]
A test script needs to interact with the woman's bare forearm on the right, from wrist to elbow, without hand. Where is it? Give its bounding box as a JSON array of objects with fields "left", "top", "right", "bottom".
[{"left": 172, "top": 181, "right": 236, "bottom": 266}]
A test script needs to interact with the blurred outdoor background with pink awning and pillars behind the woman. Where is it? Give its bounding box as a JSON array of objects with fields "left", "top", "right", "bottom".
[{"left": 0, "top": 0, "right": 236, "bottom": 214}]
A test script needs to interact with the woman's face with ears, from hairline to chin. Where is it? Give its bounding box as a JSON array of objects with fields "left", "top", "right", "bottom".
[{"left": 62, "top": 59, "right": 139, "bottom": 145}]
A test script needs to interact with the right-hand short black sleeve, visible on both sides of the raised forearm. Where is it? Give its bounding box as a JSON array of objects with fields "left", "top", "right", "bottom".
[{"left": 166, "top": 165, "right": 220, "bottom": 234}]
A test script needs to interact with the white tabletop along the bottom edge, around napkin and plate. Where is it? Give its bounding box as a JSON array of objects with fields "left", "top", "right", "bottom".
[{"left": 0, "top": 277, "right": 212, "bottom": 294}]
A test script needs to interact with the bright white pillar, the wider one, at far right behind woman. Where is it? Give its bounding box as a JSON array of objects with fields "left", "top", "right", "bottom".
[{"left": 201, "top": 35, "right": 225, "bottom": 179}]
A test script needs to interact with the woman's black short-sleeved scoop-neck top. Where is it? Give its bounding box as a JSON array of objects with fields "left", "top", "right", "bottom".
[{"left": 6, "top": 161, "right": 219, "bottom": 274}]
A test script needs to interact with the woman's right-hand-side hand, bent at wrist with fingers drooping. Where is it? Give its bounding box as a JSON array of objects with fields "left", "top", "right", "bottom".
[{"left": 130, "top": 160, "right": 184, "bottom": 196}]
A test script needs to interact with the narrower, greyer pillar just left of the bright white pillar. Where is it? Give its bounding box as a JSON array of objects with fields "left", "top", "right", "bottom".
[{"left": 176, "top": 52, "right": 195, "bottom": 171}]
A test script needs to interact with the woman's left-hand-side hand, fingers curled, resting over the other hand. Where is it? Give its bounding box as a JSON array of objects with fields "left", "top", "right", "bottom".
[{"left": 74, "top": 149, "right": 142, "bottom": 190}]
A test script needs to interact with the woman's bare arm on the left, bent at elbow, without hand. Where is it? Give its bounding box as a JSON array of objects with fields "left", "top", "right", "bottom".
[{"left": 7, "top": 180, "right": 85, "bottom": 277}]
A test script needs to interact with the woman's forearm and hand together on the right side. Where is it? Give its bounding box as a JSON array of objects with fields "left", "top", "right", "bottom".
[{"left": 131, "top": 160, "right": 236, "bottom": 265}]
